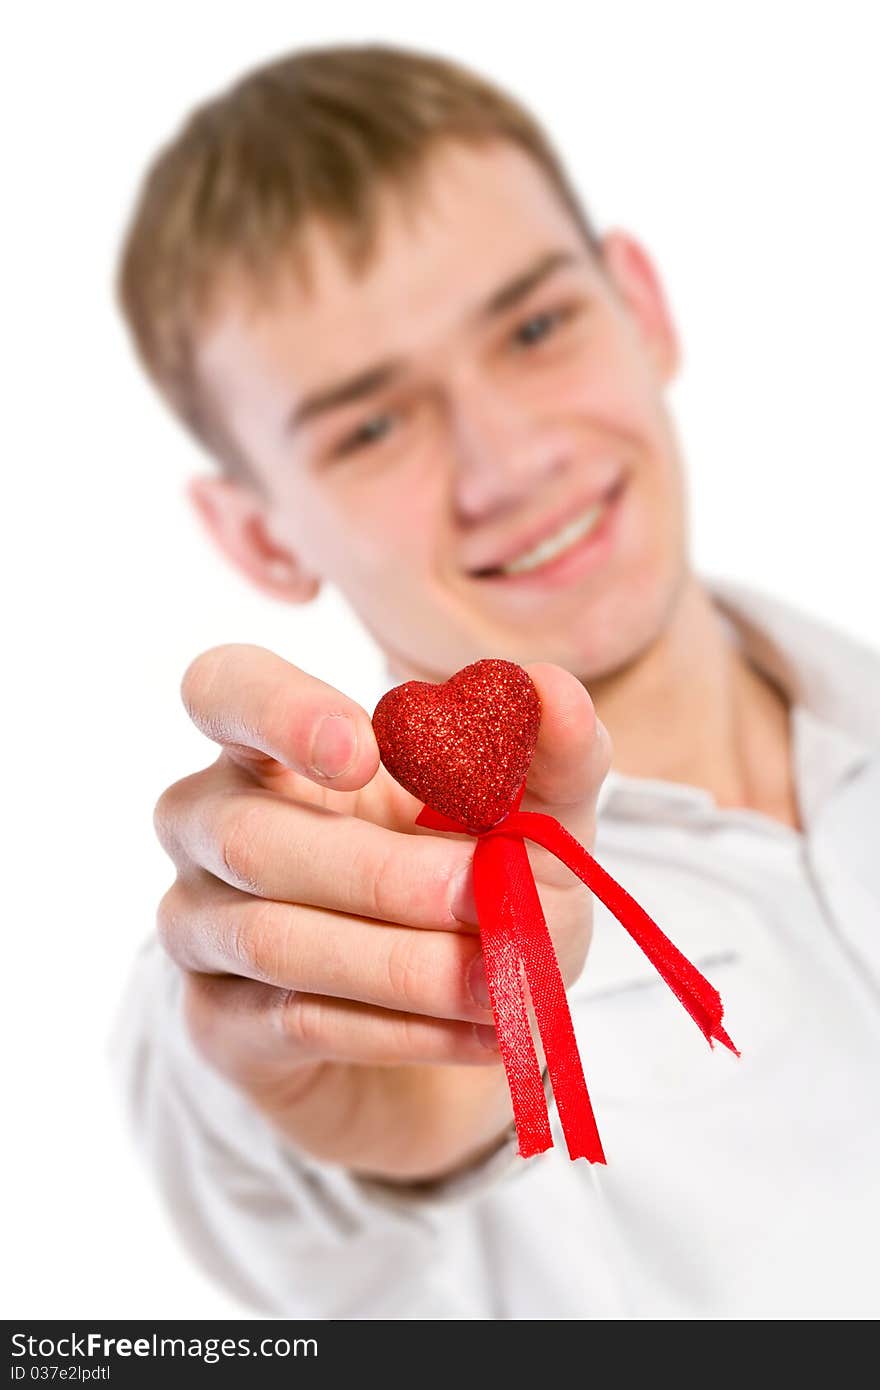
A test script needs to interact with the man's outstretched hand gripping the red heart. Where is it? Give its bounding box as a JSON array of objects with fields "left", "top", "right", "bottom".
[{"left": 156, "top": 646, "right": 610, "bottom": 1180}]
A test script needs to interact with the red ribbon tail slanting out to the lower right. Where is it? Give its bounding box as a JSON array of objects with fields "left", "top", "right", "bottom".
[{"left": 505, "top": 810, "right": 740, "bottom": 1056}]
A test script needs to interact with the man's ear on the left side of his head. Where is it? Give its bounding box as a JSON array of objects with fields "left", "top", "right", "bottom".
[{"left": 186, "top": 474, "right": 321, "bottom": 603}]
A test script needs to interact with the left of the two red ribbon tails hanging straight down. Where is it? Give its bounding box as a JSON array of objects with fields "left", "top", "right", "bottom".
[{"left": 474, "top": 838, "right": 553, "bottom": 1158}]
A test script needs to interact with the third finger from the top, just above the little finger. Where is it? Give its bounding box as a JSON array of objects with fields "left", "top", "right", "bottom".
[{"left": 157, "top": 880, "right": 492, "bottom": 1023}]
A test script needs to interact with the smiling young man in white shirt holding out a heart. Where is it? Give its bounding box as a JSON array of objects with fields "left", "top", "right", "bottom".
[{"left": 120, "top": 47, "right": 880, "bottom": 1318}]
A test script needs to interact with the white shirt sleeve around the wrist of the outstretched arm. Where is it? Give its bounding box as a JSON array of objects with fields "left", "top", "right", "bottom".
[{"left": 111, "top": 938, "right": 539, "bottom": 1319}]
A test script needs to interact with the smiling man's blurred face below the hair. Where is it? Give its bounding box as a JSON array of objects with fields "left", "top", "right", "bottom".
[{"left": 200, "top": 142, "right": 687, "bottom": 680}]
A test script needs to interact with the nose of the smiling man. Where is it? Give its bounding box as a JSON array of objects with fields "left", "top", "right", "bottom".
[{"left": 444, "top": 388, "right": 571, "bottom": 521}]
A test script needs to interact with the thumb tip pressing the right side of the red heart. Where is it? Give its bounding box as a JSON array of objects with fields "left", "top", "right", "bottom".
[{"left": 523, "top": 662, "right": 612, "bottom": 840}]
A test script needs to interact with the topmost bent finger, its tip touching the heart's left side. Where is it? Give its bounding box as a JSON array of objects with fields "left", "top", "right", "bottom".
[{"left": 181, "top": 645, "right": 380, "bottom": 791}]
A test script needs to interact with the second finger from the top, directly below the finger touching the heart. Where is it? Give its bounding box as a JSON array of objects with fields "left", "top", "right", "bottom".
[{"left": 156, "top": 781, "right": 477, "bottom": 931}]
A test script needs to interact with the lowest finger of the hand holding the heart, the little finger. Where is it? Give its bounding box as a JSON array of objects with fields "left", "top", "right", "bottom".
[{"left": 185, "top": 974, "right": 500, "bottom": 1079}]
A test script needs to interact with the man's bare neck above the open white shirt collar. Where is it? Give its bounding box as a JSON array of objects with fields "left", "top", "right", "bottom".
[{"left": 587, "top": 575, "right": 801, "bottom": 828}]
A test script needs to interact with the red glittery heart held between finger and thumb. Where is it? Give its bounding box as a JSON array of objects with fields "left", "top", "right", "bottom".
[{"left": 373, "top": 659, "right": 541, "bottom": 831}]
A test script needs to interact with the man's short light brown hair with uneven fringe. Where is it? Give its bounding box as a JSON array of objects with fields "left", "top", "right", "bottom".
[{"left": 118, "top": 44, "right": 598, "bottom": 477}]
